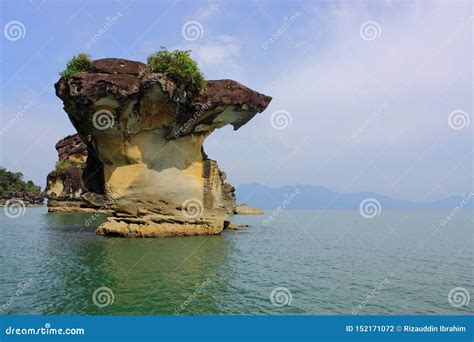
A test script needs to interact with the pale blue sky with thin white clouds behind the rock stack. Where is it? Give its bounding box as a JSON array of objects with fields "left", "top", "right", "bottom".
[{"left": 0, "top": 0, "right": 474, "bottom": 201}]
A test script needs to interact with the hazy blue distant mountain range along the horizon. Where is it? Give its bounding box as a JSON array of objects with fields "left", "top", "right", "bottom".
[{"left": 236, "top": 183, "right": 474, "bottom": 209}]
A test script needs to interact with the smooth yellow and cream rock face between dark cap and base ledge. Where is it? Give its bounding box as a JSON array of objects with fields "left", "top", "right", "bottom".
[{"left": 96, "top": 129, "right": 207, "bottom": 215}]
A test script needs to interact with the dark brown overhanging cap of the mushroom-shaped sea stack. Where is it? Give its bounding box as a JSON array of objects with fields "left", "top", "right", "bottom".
[{"left": 55, "top": 58, "right": 271, "bottom": 139}]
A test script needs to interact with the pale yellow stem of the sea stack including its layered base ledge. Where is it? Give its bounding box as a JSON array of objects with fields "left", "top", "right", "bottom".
[{"left": 78, "top": 87, "right": 232, "bottom": 236}]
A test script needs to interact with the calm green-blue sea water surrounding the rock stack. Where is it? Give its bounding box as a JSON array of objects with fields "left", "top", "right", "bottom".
[{"left": 0, "top": 208, "right": 474, "bottom": 315}]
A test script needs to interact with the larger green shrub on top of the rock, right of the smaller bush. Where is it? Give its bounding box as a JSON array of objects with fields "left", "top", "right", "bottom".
[{"left": 147, "top": 47, "right": 206, "bottom": 92}]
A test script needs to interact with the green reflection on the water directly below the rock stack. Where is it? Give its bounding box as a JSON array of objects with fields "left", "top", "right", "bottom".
[{"left": 91, "top": 236, "right": 231, "bottom": 315}]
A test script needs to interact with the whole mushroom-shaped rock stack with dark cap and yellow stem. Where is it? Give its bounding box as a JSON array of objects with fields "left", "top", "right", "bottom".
[{"left": 51, "top": 59, "right": 271, "bottom": 237}]
